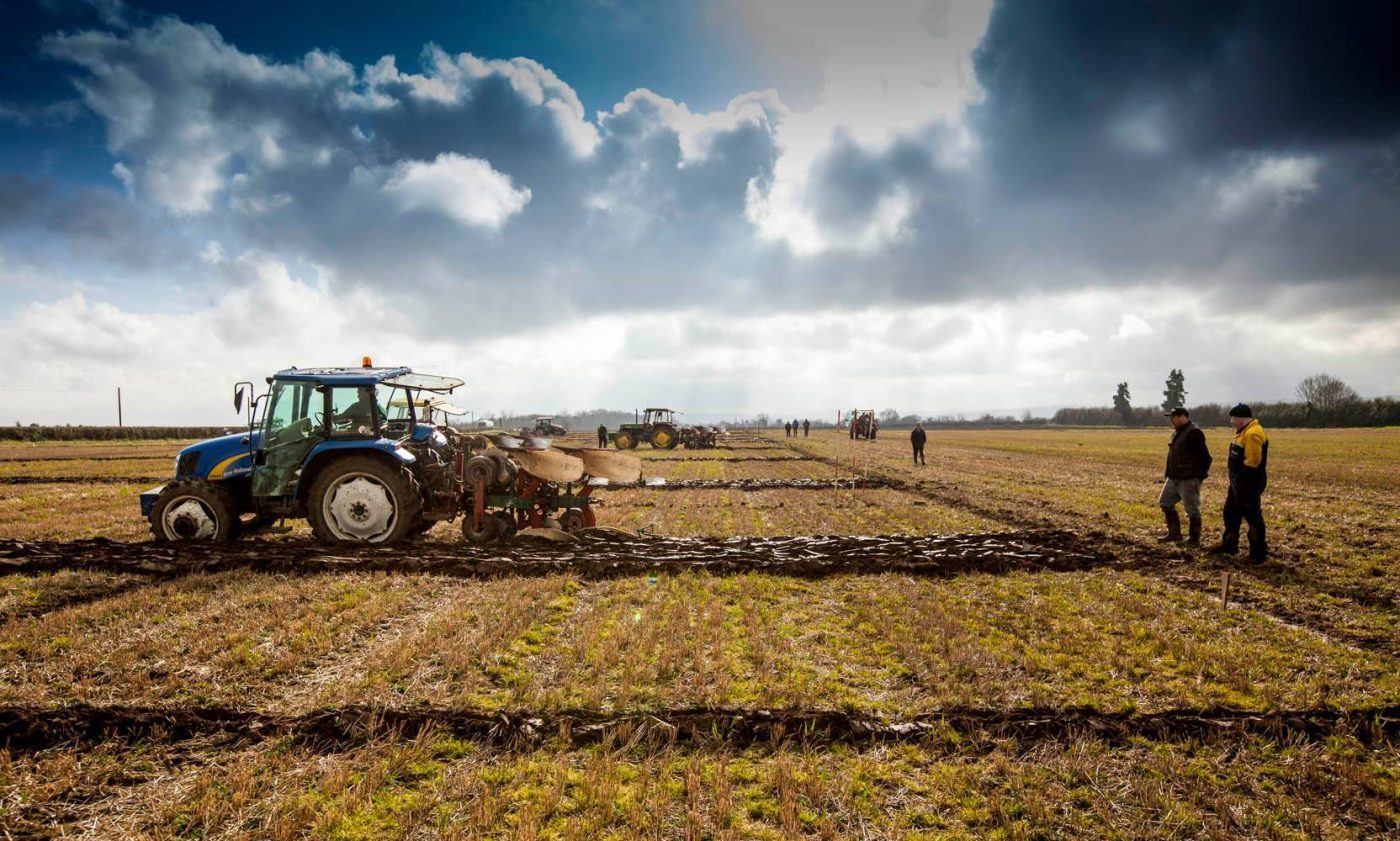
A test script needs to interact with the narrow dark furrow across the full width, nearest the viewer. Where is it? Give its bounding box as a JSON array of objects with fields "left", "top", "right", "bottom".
[{"left": 0, "top": 704, "right": 1400, "bottom": 751}]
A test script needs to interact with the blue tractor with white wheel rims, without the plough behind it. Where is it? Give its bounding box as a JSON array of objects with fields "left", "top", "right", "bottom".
[{"left": 141, "top": 360, "right": 466, "bottom": 543}]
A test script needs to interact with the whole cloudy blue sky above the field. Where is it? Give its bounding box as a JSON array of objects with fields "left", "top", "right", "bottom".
[{"left": 0, "top": 0, "right": 1400, "bottom": 425}]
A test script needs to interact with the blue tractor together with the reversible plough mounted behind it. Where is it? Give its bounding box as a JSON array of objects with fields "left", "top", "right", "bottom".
[{"left": 141, "top": 358, "right": 641, "bottom": 543}]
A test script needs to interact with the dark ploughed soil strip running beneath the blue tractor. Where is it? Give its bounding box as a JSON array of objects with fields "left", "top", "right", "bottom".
[{"left": 0, "top": 530, "right": 1116, "bottom": 579}]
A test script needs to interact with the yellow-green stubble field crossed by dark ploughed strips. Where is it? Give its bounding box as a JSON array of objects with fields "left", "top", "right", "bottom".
[{"left": 0, "top": 430, "right": 1400, "bottom": 838}]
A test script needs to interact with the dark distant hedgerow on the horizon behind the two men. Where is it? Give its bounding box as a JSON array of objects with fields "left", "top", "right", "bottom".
[{"left": 1050, "top": 397, "right": 1400, "bottom": 428}]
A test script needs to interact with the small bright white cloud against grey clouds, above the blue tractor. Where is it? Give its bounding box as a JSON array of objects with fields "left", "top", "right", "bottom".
[{"left": 382, "top": 153, "right": 531, "bottom": 231}]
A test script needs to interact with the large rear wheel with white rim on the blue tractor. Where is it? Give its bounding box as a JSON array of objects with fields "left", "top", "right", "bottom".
[{"left": 307, "top": 456, "right": 423, "bottom": 543}]
